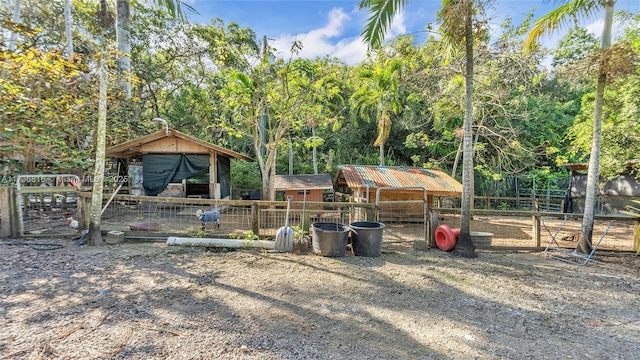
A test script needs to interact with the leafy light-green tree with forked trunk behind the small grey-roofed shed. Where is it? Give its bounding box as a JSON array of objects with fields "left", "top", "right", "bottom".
[{"left": 219, "top": 41, "right": 330, "bottom": 200}]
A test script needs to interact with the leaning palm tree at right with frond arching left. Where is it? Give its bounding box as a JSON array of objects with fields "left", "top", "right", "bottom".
[{"left": 524, "top": 0, "right": 616, "bottom": 254}]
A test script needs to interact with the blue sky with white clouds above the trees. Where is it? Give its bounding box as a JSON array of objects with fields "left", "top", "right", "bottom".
[{"left": 183, "top": 0, "right": 640, "bottom": 65}]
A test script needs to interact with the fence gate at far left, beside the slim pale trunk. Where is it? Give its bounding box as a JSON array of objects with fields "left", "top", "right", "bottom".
[{"left": 15, "top": 174, "right": 80, "bottom": 237}]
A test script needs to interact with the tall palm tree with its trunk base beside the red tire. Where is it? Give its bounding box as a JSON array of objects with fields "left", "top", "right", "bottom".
[{"left": 360, "top": 0, "right": 478, "bottom": 257}]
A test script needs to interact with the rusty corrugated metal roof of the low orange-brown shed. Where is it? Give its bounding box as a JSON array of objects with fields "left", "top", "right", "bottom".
[{"left": 335, "top": 165, "right": 462, "bottom": 196}]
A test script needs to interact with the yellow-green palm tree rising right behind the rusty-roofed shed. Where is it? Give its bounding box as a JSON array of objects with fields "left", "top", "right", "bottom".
[{"left": 351, "top": 59, "right": 402, "bottom": 166}]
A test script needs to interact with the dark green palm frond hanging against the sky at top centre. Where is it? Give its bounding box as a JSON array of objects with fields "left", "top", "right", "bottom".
[{"left": 358, "top": 0, "right": 409, "bottom": 49}]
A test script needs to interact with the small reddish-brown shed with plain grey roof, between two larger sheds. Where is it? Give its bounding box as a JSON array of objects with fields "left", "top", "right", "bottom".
[{"left": 274, "top": 174, "right": 333, "bottom": 201}]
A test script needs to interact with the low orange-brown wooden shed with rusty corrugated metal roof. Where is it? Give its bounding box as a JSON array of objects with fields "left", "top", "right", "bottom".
[{"left": 335, "top": 165, "right": 462, "bottom": 205}]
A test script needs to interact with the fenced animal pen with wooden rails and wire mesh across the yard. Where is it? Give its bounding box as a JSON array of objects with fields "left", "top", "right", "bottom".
[{"left": 0, "top": 182, "right": 638, "bottom": 251}]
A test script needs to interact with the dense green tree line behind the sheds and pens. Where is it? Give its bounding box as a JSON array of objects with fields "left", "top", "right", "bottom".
[{"left": 0, "top": 0, "right": 640, "bottom": 200}]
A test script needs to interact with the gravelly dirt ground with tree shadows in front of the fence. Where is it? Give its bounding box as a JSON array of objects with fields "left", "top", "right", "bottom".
[{"left": 0, "top": 239, "right": 640, "bottom": 359}]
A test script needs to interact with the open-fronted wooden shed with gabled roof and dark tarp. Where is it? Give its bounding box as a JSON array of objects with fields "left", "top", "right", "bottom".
[{"left": 106, "top": 128, "right": 253, "bottom": 199}]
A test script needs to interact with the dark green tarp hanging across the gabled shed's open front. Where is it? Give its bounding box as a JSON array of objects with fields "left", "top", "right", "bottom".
[{"left": 142, "top": 154, "right": 209, "bottom": 196}]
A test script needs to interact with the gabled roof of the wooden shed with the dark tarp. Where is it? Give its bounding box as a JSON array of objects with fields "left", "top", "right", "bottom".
[{"left": 106, "top": 129, "right": 253, "bottom": 161}]
